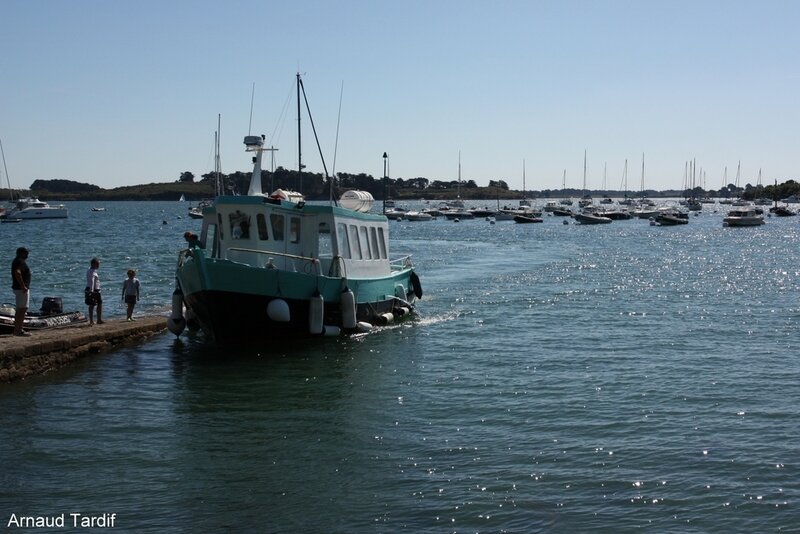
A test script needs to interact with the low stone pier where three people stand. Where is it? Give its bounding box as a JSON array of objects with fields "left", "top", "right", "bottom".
[{"left": 0, "top": 317, "right": 167, "bottom": 383}]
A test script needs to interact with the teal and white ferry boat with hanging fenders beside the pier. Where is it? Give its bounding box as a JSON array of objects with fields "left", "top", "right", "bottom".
[{"left": 167, "top": 76, "right": 422, "bottom": 344}]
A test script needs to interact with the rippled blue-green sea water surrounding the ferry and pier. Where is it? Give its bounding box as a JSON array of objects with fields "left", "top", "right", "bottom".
[{"left": 0, "top": 202, "right": 800, "bottom": 533}]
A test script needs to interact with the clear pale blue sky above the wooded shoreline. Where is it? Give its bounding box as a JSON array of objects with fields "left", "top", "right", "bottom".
[{"left": 0, "top": 0, "right": 800, "bottom": 191}]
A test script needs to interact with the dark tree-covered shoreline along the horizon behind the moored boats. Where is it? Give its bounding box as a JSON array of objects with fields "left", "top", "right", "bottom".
[{"left": 6, "top": 167, "right": 800, "bottom": 201}]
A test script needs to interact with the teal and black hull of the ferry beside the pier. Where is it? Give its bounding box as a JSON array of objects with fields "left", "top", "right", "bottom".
[{"left": 176, "top": 252, "right": 421, "bottom": 343}]
